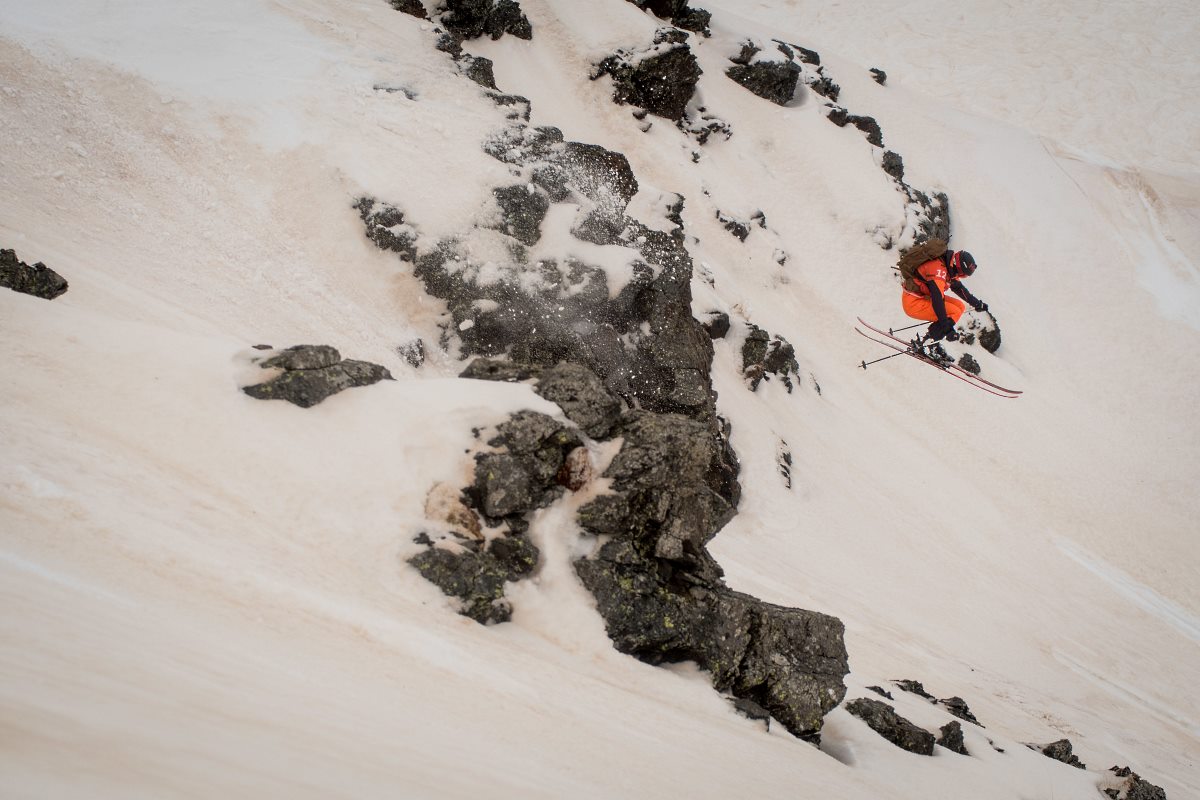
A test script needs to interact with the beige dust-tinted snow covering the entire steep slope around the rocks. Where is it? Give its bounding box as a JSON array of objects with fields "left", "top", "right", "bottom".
[{"left": 0, "top": 0, "right": 1200, "bottom": 800}]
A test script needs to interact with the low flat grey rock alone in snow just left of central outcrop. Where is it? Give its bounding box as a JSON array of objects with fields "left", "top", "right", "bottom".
[{"left": 242, "top": 344, "right": 392, "bottom": 408}]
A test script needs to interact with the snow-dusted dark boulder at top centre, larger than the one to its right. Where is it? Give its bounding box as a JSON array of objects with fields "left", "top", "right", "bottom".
[{"left": 592, "top": 43, "right": 703, "bottom": 121}]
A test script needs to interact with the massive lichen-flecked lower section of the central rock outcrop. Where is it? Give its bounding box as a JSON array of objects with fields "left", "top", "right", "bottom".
[{"left": 576, "top": 411, "right": 847, "bottom": 735}]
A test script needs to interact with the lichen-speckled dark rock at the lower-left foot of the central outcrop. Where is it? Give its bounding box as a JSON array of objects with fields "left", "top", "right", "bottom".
[{"left": 408, "top": 534, "right": 539, "bottom": 625}]
